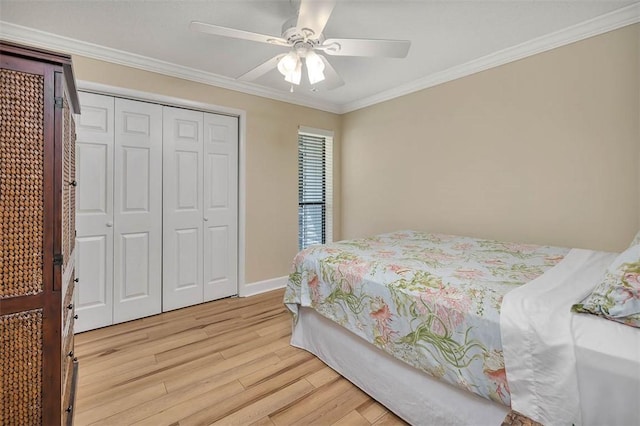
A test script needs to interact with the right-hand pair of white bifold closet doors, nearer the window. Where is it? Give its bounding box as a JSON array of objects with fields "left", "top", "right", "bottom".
[{"left": 163, "top": 107, "right": 238, "bottom": 311}]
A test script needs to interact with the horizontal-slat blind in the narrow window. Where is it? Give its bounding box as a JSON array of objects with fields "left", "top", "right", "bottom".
[{"left": 298, "top": 133, "right": 327, "bottom": 250}]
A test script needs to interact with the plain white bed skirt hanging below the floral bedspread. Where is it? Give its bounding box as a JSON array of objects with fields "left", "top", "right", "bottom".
[{"left": 291, "top": 307, "right": 510, "bottom": 426}]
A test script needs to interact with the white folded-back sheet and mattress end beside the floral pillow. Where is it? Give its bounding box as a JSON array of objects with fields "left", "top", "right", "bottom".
[{"left": 501, "top": 249, "right": 640, "bottom": 426}]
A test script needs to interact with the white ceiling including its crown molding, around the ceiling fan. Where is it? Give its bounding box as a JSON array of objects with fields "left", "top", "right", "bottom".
[{"left": 0, "top": 0, "right": 640, "bottom": 112}]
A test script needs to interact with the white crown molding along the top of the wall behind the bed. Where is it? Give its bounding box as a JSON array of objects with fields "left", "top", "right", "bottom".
[{"left": 340, "top": 2, "right": 640, "bottom": 114}]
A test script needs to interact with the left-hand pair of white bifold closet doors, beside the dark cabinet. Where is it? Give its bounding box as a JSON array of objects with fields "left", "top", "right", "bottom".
[{"left": 76, "top": 92, "right": 162, "bottom": 331}]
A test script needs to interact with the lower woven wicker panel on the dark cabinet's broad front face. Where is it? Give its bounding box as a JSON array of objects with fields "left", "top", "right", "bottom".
[{"left": 0, "top": 309, "right": 43, "bottom": 426}]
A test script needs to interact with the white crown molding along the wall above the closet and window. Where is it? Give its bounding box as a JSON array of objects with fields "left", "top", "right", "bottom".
[{"left": 0, "top": 21, "right": 340, "bottom": 113}]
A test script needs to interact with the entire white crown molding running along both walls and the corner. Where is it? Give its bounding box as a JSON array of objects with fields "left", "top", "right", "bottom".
[{"left": 0, "top": 2, "right": 640, "bottom": 114}]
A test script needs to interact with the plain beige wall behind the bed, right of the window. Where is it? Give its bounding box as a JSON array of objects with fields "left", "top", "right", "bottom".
[{"left": 342, "top": 24, "right": 640, "bottom": 250}]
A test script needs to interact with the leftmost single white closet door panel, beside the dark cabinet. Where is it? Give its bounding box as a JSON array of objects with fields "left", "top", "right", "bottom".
[{"left": 75, "top": 92, "right": 114, "bottom": 332}]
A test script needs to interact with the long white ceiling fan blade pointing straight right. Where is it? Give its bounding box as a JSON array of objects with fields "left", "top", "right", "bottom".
[{"left": 316, "top": 38, "right": 411, "bottom": 58}]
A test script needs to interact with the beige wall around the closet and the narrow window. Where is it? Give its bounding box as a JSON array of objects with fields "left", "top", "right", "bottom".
[{"left": 73, "top": 56, "right": 341, "bottom": 283}]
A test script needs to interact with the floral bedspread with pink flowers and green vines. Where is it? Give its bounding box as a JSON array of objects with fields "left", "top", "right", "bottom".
[{"left": 284, "top": 231, "right": 569, "bottom": 406}]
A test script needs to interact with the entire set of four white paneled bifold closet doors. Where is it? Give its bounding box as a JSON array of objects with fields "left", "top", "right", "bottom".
[{"left": 76, "top": 92, "right": 238, "bottom": 331}]
